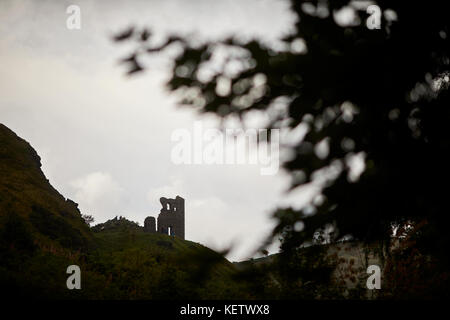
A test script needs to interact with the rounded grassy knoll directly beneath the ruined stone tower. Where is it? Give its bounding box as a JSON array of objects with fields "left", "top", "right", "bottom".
[{"left": 84, "top": 218, "right": 242, "bottom": 299}]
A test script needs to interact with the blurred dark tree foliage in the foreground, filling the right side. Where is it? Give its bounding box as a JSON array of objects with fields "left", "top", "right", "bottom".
[{"left": 115, "top": 0, "right": 450, "bottom": 264}]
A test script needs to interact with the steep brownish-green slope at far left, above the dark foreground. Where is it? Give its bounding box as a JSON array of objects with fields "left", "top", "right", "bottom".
[{"left": 0, "top": 124, "right": 92, "bottom": 250}]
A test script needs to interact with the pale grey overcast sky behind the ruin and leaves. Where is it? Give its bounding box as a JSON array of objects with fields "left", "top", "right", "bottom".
[{"left": 0, "top": 0, "right": 324, "bottom": 260}]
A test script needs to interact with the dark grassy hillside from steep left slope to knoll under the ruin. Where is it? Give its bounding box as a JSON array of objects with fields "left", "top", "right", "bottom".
[{"left": 0, "top": 124, "right": 250, "bottom": 299}]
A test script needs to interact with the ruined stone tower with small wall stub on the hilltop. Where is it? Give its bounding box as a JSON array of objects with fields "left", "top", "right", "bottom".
[{"left": 144, "top": 196, "right": 184, "bottom": 240}]
